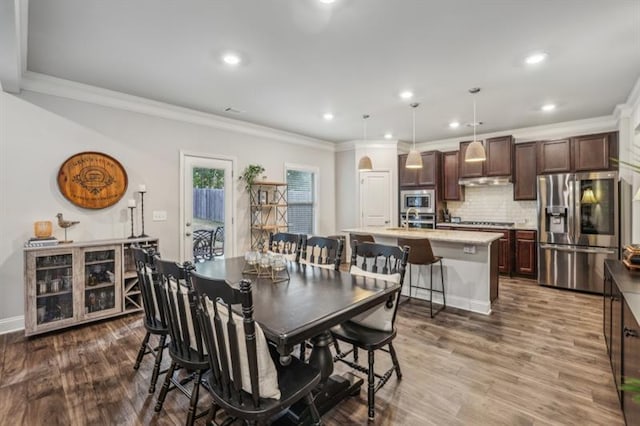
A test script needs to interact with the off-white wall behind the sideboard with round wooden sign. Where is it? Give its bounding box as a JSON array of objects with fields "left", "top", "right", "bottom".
[{"left": 0, "top": 91, "right": 336, "bottom": 322}]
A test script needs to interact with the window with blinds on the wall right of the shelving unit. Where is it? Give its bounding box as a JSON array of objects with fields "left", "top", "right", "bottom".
[{"left": 287, "top": 167, "right": 316, "bottom": 234}]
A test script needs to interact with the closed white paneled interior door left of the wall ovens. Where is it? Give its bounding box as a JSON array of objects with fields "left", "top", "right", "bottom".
[{"left": 360, "top": 171, "right": 391, "bottom": 226}]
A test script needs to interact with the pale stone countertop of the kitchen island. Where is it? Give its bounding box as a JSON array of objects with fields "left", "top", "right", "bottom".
[{"left": 342, "top": 227, "right": 502, "bottom": 244}]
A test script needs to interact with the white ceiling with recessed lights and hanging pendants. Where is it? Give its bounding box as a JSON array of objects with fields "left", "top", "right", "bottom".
[{"left": 20, "top": 0, "right": 640, "bottom": 142}]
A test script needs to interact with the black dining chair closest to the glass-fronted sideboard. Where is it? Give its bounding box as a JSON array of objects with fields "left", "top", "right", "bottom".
[{"left": 131, "top": 245, "right": 169, "bottom": 393}]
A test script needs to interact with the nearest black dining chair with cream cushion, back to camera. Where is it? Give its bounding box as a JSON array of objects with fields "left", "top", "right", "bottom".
[{"left": 192, "top": 273, "right": 321, "bottom": 424}]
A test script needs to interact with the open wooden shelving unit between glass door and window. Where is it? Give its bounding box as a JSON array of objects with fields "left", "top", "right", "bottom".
[{"left": 249, "top": 182, "right": 289, "bottom": 250}]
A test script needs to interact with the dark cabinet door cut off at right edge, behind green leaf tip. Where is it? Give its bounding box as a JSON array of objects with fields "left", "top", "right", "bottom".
[{"left": 622, "top": 301, "right": 640, "bottom": 425}]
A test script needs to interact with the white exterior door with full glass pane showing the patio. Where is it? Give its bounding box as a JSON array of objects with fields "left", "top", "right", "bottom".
[{"left": 180, "top": 153, "right": 235, "bottom": 261}]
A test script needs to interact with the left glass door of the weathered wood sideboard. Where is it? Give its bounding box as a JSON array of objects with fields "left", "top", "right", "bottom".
[{"left": 35, "top": 253, "right": 74, "bottom": 326}]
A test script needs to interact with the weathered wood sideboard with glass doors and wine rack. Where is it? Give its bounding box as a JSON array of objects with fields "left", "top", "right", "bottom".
[{"left": 24, "top": 238, "right": 158, "bottom": 336}]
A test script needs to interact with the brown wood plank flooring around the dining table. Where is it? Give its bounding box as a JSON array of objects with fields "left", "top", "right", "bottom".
[{"left": 0, "top": 277, "right": 623, "bottom": 425}]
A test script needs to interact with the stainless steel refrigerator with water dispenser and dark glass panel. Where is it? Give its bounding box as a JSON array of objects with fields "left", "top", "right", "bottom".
[{"left": 538, "top": 172, "right": 619, "bottom": 293}]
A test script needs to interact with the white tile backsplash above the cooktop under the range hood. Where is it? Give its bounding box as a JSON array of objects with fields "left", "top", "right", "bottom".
[{"left": 447, "top": 184, "right": 537, "bottom": 227}]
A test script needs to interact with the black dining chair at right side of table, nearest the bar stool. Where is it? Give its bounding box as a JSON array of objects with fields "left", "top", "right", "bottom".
[{"left": 331, "top": 243, "right": 410, "bottom": 420}]
